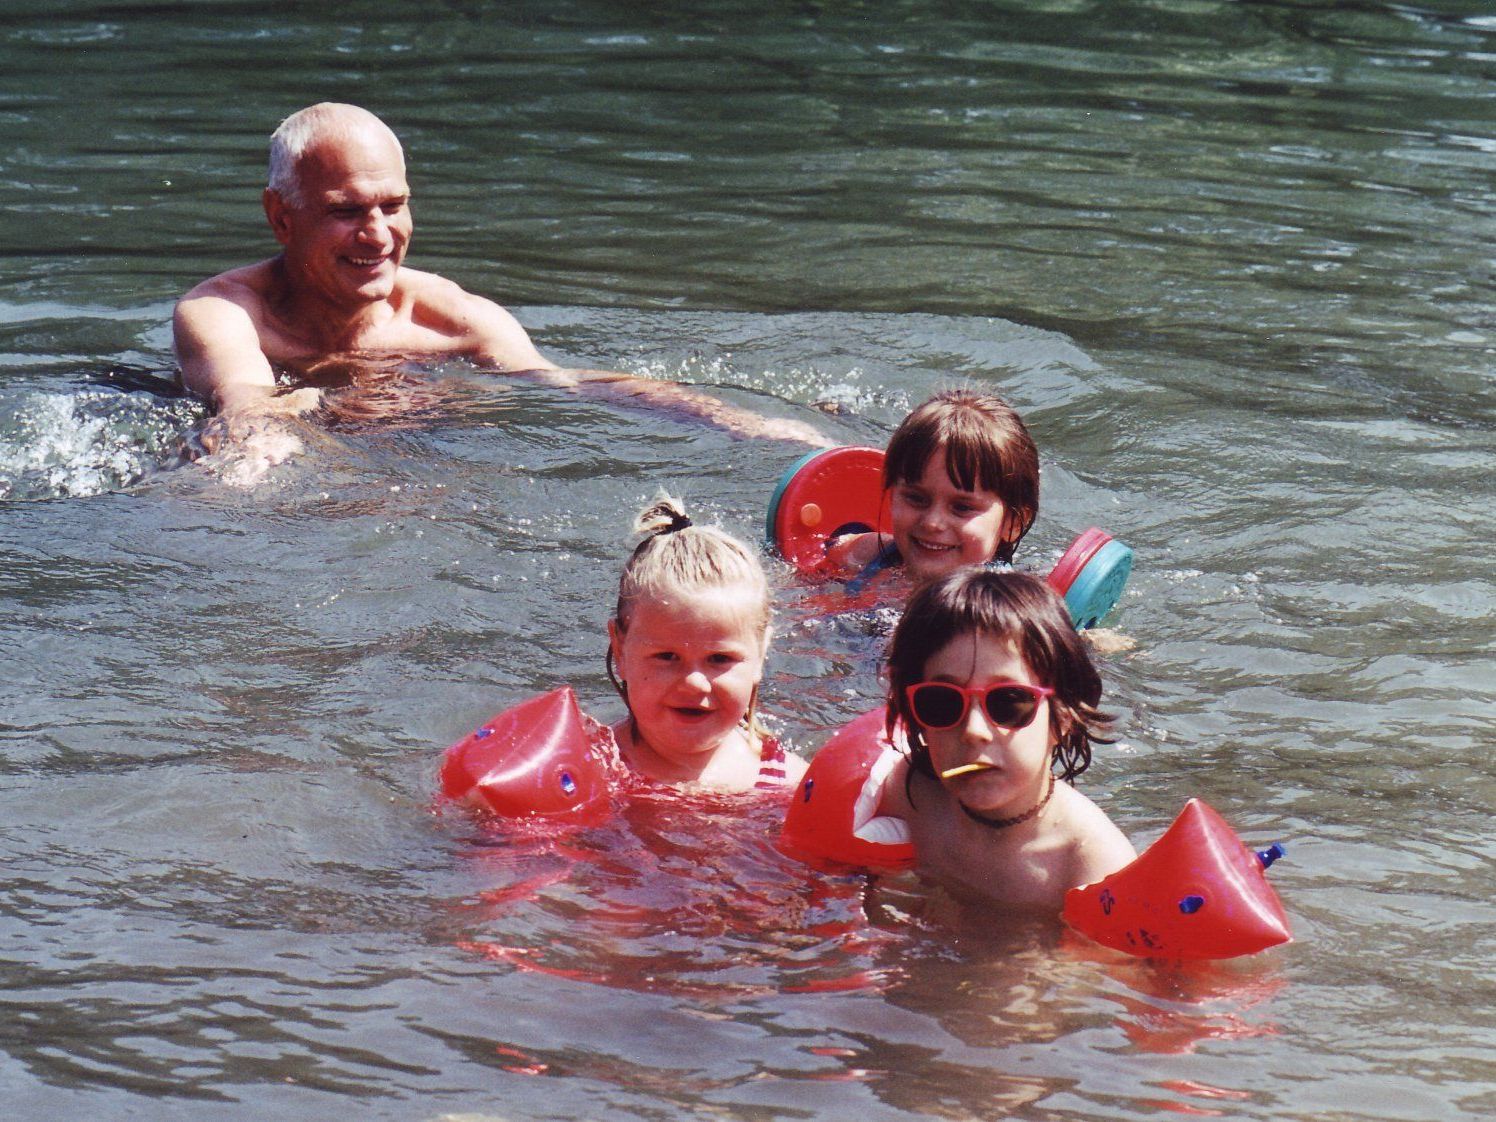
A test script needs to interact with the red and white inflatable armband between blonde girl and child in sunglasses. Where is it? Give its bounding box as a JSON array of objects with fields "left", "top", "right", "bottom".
[{"left": 779, "top": 709, "right": 914, "bottom": 869}]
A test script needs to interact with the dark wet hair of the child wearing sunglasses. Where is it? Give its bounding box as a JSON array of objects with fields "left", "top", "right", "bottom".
[{"left": 889, "top": 567, "right": 1112, "bottom": 779}]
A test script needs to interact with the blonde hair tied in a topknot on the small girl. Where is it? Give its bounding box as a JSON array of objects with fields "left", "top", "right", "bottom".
[{"left": 613, "top": 494, "right": 769, "bottom": 633}]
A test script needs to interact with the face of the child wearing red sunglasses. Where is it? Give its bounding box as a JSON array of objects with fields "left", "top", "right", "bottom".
[{"left": 923, "top": 631, "right": 1055, "bottom": 818}]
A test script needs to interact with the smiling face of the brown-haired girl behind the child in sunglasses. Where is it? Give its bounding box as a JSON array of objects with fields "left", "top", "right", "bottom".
[{"left": 889, "top": 450, "right": 1007, "bottom": 580}]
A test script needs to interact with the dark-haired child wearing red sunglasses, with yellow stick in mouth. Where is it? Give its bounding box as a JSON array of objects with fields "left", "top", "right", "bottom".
[{"left": 878, "top": 568, "right": 1135, "bottom": 913}]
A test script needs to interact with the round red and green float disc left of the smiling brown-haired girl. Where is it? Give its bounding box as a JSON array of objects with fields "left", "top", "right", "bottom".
[{"left": 764, "top": 447, "right": 889, "bottom": 573}]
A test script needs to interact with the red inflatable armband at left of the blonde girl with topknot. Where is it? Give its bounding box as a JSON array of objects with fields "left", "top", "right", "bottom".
[{"left": 441, "top": 685, "right": 610, "bottom": 823}]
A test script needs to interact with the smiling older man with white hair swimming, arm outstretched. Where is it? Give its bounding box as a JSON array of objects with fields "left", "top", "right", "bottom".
[{"left": 174, "top": 102, "right": 827, "bottom": 459}]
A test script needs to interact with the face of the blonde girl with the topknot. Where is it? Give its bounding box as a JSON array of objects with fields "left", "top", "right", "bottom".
[{"left": 609, "top": 583, "right": 769, "bottom": 767}]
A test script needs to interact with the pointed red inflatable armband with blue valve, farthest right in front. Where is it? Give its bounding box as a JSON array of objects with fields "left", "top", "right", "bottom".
[{"left": 1062, "top": 799, "right": 1293, "bottom": 959}]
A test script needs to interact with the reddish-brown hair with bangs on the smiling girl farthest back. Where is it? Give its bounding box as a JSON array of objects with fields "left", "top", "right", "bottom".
[{"left": 883, "top": 389, "right": 1038, "bottom": 562}]
